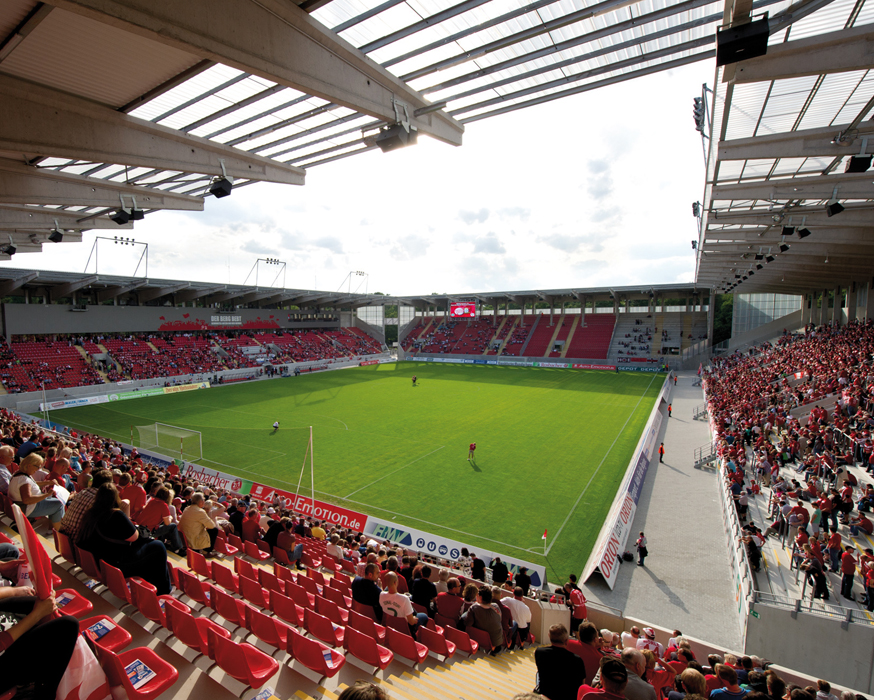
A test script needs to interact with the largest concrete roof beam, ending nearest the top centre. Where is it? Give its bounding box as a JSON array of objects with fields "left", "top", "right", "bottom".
[{"left": 55, "top": 0, "right": 464, "bottom": 145}]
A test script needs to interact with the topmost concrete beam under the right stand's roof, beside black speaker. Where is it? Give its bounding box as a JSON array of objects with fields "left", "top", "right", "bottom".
[{"left": 734, "top": 24, "right": 874, "bottom": 84}]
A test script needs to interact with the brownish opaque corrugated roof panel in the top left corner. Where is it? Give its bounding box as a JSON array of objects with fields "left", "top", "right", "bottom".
[{"left": 3, "top": 8, "right": 201, "bottom": 108}]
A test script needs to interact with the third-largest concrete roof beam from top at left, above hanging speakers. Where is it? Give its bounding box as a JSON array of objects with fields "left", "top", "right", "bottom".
[{"left": 0, "top": 159, "right": 203, "bottom": 211}]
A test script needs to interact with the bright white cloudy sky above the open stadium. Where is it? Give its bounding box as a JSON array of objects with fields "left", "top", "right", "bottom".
[{"left": 3, "top": 62, "right": 713, "bottom": 294}]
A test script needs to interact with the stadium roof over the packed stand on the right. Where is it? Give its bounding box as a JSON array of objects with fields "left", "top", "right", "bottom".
[{"left": 696, "top": 0, "right": 874, "bottom": 294}]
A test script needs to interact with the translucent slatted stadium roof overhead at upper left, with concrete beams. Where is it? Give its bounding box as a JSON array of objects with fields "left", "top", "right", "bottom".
[{"left": 0, "top": 0, "right": 784, "bottom": 252}]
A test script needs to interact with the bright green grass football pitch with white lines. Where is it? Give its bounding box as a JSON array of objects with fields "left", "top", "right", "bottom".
[{"left": 51, "top": 362, "right": 664, "bottom": 582}]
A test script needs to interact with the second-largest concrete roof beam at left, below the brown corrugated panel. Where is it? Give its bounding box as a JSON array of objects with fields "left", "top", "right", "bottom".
[{"left": 0, "top": 74, "right": 305, "bottom": 185}]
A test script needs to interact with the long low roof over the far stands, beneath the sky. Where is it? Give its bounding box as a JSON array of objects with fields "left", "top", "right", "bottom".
[{"left": 0, "top": 268, "right": 710, "bottom": 309}]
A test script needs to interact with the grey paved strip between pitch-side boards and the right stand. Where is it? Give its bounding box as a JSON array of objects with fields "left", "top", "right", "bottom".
[{"left": 584, "top": 371, "right": 742, "bottom": 650}]
